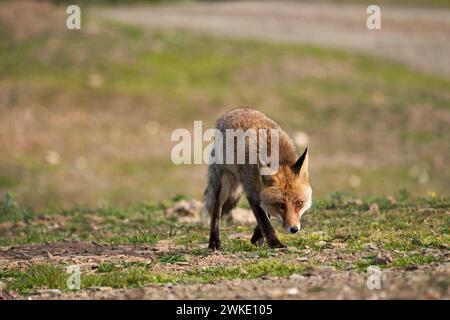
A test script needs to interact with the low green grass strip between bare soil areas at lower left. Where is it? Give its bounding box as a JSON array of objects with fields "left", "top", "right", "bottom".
[{"left": 0, "top": 259, "right": 305, "bottom": 294}]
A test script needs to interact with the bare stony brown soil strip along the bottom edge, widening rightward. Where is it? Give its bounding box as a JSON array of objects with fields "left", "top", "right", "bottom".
[{"left": 23, "top": 265, "right": 450, "bottom": 299}]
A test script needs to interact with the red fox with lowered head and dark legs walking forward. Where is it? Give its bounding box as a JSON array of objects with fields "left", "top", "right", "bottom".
[{"left": 204, "top": 108, "right": 312, "bottom": 250}]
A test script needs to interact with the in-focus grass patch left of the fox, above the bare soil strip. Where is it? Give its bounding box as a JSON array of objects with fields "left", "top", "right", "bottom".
[{"left": 0, "top": 195, "right": 183, "bottom": 245}]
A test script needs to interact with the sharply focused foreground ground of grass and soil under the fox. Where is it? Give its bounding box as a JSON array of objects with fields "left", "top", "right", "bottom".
[{"left": 0, "top": 194, "right": 450, "bottom": 299}]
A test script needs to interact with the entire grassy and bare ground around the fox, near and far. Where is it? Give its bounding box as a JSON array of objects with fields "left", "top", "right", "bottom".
[{"left": 0, "top": 0, "right": 450, "bottom": 299}]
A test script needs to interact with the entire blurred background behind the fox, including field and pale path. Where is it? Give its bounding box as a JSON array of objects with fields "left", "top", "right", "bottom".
[{"left": 0, "top": 0, "right": 450, "bottom": 208}]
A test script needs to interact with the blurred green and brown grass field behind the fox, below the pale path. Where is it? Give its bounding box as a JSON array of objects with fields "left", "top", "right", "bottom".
[{"left": 0, "top": 5, "right": 450, "bottom": 208}]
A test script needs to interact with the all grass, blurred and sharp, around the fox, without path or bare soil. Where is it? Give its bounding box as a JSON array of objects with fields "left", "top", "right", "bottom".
[{"left": 0, "top": 1, "right": 450, "bottom": 295}]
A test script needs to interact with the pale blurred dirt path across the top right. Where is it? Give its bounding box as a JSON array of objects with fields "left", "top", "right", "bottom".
[{"left": 94, "top": 1, "right": 450, "bottom": 76}]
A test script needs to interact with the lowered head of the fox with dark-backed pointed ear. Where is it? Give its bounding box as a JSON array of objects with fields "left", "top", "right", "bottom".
[{"left": 259, "top": 149, "right": 312, "bottom": 233}]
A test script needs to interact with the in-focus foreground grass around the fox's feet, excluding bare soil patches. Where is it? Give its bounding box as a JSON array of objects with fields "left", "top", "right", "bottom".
[{"left": 0, "top": 191, "right": 450, "bottom": 295}]
